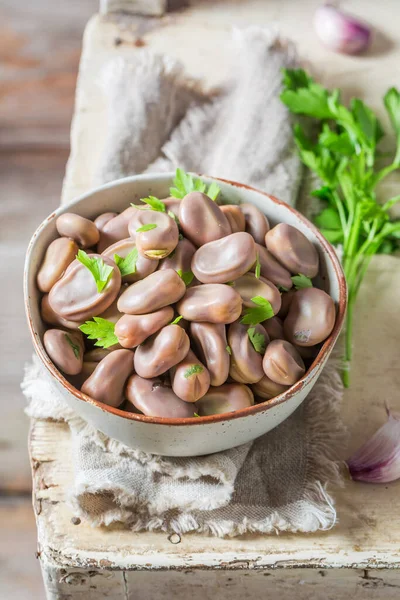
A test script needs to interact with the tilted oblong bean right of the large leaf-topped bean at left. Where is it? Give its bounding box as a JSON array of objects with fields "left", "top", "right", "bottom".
[{"left": 118, "top": 269, "right": 186, "bottom": 315}]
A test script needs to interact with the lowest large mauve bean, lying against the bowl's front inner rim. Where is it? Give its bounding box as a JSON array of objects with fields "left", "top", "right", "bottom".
[{"left": 126, "top": 375, "right": 196, "bottom": 419}]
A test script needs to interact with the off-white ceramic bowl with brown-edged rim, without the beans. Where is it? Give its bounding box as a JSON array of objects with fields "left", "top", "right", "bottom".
[{"left": 24, "top": 173, "right": 346, "bottom": 456}]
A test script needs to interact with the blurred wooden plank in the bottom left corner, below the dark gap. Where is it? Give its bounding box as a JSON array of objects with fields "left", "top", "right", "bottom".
[{"left": 0, "top": 497, "right": 43, "bottom": 600}]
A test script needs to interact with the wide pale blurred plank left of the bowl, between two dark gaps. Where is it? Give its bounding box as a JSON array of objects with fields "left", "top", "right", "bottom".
[{"left": 0, "top": 150, "right": 67, "bottom": 491}]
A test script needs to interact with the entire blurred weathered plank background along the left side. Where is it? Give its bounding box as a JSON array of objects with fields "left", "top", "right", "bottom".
[{"left": 0, "top": 0, "right": 98, "bottom": 600}]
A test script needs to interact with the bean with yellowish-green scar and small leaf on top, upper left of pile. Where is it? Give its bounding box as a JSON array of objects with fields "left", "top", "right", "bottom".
[{"left": 129, "top": 210, "right": 179, "bottom": 261}]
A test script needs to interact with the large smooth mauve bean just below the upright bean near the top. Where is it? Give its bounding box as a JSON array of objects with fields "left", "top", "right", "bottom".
[{"left": 192, "top": 231, "right": 256, "bottom": 283}]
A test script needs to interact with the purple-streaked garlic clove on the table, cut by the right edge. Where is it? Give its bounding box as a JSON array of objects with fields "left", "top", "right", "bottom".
[{"left": 347, "top": 409, "right": 400, "bottom": 483}]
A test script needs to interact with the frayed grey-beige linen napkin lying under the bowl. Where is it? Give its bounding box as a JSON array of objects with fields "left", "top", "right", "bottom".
[{"left": 23, "top": 28, "right": 343, "bottom": 536}]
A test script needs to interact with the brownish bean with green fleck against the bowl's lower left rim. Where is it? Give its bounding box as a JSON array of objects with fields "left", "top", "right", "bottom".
[{"left": 43, "top": 329, "right": 84, "bottom": 375}]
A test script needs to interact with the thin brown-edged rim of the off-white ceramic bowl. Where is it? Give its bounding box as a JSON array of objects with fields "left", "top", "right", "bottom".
[{"left": 24, "top": 172, "right": 347, "bottom": 426}]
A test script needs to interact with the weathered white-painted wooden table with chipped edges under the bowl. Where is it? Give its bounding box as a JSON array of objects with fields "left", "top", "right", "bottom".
[{"left": 30, "top": 0, "right": 400, "bottom": 600}]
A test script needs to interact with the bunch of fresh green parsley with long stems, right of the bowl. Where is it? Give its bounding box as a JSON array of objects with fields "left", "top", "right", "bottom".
[{"left": 281, "top": 69, "right": 400, "bottom": 386}]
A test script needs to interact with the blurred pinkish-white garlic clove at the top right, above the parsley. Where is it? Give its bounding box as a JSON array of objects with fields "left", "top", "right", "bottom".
[{"left": 314, "top": 4, "right": 371, "bottom": 54}]
